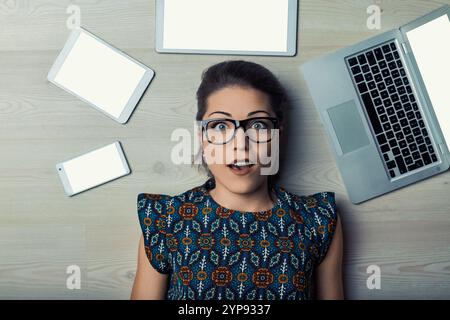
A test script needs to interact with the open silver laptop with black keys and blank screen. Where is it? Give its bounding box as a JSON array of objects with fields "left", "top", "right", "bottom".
[{"left": 301, "top": 5, "right": 450, "bottom": 204}]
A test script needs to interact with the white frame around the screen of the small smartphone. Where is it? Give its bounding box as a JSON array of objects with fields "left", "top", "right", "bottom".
[{"left": 56, "top": 141, "right": 131, "bottom": 197}]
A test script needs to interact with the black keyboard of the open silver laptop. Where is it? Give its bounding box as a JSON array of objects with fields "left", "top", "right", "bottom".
[{"left": 346, "top": 41, "right": 438, "bottom": 178}]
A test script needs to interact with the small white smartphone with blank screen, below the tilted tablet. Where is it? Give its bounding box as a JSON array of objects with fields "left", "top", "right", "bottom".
[{"left": 56, "top": 141, "right": 131, "bottom": 196}]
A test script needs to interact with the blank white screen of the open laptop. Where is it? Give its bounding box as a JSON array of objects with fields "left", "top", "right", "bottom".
[{"left": 406, "top": 15, "right": 450, "bottom": 147}]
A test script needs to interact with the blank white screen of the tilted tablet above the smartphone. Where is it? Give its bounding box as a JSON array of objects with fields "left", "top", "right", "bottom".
[{"left": 55, "top": 31, "right": 145, "bottom": 118}]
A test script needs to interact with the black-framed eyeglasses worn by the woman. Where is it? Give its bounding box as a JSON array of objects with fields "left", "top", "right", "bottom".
[{"left": 201, "top": 117, "right": 278, "bottom": 144}]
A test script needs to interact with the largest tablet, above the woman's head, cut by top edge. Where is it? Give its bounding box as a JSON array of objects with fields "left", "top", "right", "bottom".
[{"left": 155, "top": 0, "right": 298, "bottom": 56}]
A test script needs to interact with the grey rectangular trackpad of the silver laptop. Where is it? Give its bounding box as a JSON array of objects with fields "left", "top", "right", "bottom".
[{"left": 327, "top": 100, "right": 370, "bottom": 154}]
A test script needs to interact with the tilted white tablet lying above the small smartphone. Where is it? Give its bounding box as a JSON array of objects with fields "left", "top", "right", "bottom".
[{"left": 47, "top": 28, "right": 154, "bottom": 123}]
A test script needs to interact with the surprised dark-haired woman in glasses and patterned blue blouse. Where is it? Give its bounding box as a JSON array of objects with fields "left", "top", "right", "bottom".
[{"left": 131, "top": 61, "right": 343, "bottom": 300}]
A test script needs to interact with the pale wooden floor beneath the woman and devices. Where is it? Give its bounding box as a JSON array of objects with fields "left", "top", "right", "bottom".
[{"left": 0, "top": 0, "right": 450, "bottom": 299}]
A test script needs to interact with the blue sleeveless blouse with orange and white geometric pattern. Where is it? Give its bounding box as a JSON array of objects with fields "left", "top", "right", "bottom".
[{"left": 137, "top": 178, "right": 337, "bottom": 300}]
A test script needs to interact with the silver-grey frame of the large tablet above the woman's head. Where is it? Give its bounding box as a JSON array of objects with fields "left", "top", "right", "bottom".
[{"left": 155, "top": 0, "right": 298, "bottom": 57}]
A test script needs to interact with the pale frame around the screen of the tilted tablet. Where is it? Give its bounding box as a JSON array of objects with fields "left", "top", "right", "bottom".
[{"left": 47, "top": 27, "right": 155, "bottom": 124}]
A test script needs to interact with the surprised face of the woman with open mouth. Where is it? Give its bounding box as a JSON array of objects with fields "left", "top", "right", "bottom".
[{"left": 202, "top": 86, "right": 278, "bottom": 193}]
